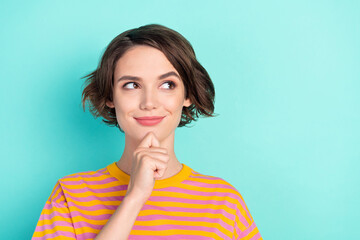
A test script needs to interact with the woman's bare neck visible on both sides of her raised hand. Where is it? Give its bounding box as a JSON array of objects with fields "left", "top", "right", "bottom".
[{"left": 117, "top": 131, "right": 182, "bottom": 179}]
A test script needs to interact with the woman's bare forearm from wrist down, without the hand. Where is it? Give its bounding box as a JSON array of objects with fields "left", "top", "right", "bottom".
[{"left": 94, "top": 195, "right": 145, "bottom": 240}]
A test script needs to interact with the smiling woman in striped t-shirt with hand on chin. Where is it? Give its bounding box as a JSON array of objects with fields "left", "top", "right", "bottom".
[{"left": 33, "top": 24, "right": 262, "bottom": 240}]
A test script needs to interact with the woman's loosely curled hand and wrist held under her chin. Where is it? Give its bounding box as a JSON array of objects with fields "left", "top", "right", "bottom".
[{"left": 125, "top": 132, "right": 170, "bottom": 203}]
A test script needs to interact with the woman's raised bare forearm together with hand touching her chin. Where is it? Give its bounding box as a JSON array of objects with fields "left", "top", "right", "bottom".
[{"left": 95, "top": 132, "right": 169, "bottom": 240}]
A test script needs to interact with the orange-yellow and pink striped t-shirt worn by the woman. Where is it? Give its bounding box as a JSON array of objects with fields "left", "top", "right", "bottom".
[{"left": 32, "top": 162, "right": 262, "bottom": 240}]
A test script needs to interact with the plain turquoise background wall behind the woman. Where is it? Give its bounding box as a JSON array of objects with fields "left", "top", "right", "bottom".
[{"left": 0, "top": 0, "right": 360, "bottom": 240}]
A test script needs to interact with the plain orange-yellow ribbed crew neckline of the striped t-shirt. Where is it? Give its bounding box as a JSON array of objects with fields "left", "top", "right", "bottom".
[{"left": 107, "top": 162, "right": 191, "bottom": 189}]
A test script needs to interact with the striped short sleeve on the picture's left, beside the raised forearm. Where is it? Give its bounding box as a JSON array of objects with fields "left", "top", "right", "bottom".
[{"left": 32, "top": 181, "right": 76, "bottom": 240}]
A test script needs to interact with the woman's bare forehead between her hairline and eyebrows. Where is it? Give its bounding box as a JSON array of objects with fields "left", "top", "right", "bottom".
[{"left": 114, "top": 45, "right": 177, "bottom": 76}]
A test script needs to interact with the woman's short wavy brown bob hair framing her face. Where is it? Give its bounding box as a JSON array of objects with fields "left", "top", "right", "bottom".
[{"left": 81, "top": 24, "right": 215, "bottom": 132}]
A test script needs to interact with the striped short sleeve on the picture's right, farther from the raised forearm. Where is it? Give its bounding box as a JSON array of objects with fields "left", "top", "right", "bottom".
[{"left": 233, "top": 193, "right": 262, "bottom": 240}]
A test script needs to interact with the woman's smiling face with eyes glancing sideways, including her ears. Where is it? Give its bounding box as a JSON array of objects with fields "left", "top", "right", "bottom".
[{"left": 107, "top": 45, "right": 191, "bottom": 141}]
